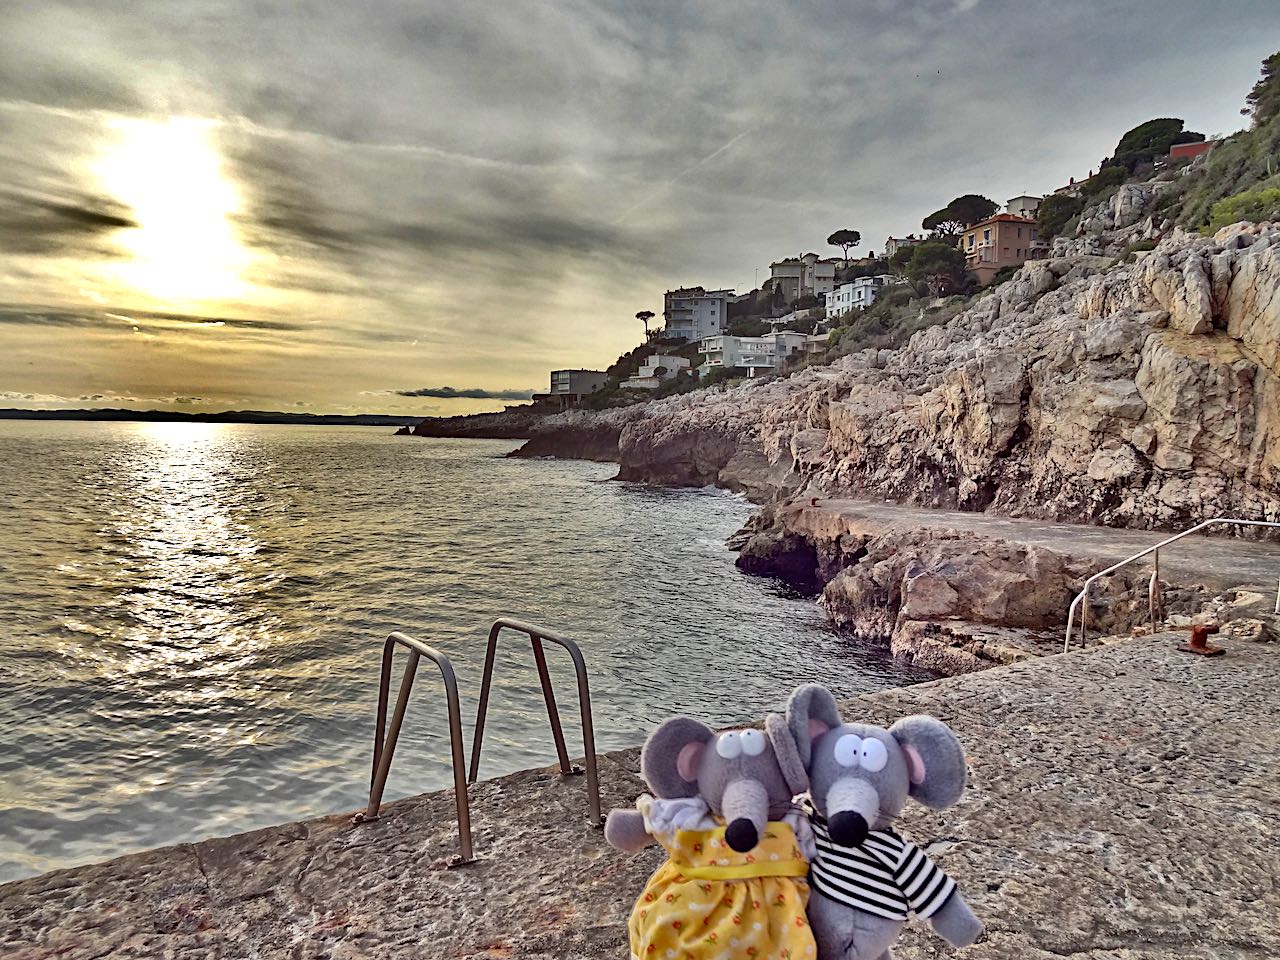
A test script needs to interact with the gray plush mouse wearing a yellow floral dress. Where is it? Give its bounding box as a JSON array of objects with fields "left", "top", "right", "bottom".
[{"left": 604, "top": 714, "right": 817, "bottom": 960}]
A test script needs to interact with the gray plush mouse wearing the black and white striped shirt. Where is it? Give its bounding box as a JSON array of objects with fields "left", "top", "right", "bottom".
[{"left": 774, "top": 684, "right": 982, "bottom": 960}]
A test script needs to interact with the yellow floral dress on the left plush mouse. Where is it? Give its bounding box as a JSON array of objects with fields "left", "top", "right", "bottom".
[{"left": 627, "top": 797, "right": 818, "bottom": 960}]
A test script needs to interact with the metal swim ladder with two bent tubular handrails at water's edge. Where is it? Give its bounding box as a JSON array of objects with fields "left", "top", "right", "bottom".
[{"left": 352, "top": 617, "right": 603, "bottom": 867}]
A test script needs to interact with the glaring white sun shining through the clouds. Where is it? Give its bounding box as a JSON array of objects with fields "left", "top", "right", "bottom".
[{"left": 95, "top": 118, "right": 250, "bottom": 303}]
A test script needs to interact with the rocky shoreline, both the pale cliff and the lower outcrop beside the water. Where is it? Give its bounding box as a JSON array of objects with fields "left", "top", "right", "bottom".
[{"left": 404, "top": 207, "right": 1280, "bottom": 672}]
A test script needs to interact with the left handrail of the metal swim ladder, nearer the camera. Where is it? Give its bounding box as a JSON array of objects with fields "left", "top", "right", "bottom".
[{"left": 355, "top": 632, "right": 475, "bottom": 867}]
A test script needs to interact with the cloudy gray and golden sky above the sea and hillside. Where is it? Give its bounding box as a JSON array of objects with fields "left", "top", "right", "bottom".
[{"left": 0, "top": 0, "right": 1280, "bottom": 416}]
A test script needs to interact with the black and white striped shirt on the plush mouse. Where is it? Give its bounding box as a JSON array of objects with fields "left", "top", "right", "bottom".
[{"left": 808, "top": 808, "right": 956, "bottom": 920}]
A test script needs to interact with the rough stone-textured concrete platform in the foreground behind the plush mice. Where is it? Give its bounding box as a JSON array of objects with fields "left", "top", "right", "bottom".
[{"left": 0, "top": 635, "right": 1280, "bottom": 960}]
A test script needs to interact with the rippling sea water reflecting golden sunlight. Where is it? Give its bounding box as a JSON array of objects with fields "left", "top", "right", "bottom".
[{"left": 0, "top": 421, "right": 923, "bottom": 881}]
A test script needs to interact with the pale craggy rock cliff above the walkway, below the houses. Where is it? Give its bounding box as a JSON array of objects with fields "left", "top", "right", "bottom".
[{"left": 524, "top": 213, "right": 1280, "bottom": 527}]
